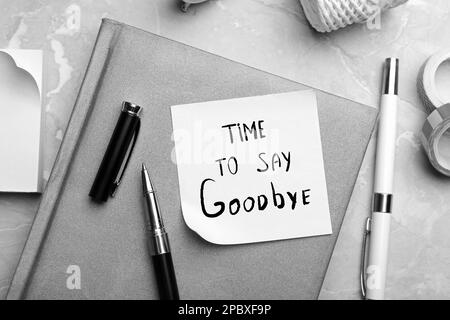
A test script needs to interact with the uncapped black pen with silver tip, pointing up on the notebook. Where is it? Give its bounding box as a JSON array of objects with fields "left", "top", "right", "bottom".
[{"left": 142, "top": 164, "right": 180, "bottom": 300}]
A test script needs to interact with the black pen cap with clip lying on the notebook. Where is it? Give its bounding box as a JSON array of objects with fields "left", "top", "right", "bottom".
[{"left": 89, "top": 102, "right": 142, "bottom": 202}]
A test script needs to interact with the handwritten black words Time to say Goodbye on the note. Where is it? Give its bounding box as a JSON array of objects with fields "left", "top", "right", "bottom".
[{"left": 200, "top": 120, "right": 311, "bottom": 218}]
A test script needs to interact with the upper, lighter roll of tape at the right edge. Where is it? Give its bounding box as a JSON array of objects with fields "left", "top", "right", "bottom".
[{"left": 417, "top": 51, "right": 450, "bottom": 113}]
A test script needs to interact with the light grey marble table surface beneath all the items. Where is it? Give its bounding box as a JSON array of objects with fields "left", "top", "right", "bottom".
[{"left": 0, "top": 0, "right": 450, "bottom": 299}]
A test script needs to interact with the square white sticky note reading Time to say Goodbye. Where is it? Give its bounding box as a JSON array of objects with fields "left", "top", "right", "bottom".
[{"left": 171, "top": 90, "right": 332, "bottom": 245}]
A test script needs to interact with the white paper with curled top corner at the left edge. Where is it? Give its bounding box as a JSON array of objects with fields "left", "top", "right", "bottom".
[{"left": 0, "top": 50, "right": 43, "bottom": 192}]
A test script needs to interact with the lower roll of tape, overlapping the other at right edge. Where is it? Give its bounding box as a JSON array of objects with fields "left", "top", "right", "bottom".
[{"left": 421, "top": 104, "right": 450, "bottom": 176}]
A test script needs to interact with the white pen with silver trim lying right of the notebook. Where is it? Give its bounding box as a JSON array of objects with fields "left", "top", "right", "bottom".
[{"left": 361, "top": 58, "right": 399, "bottom": 300}]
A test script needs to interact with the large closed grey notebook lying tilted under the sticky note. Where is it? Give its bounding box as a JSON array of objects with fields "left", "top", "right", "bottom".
[{"left": 8, "top": 20, "right": 377, "bottom": 299}]
